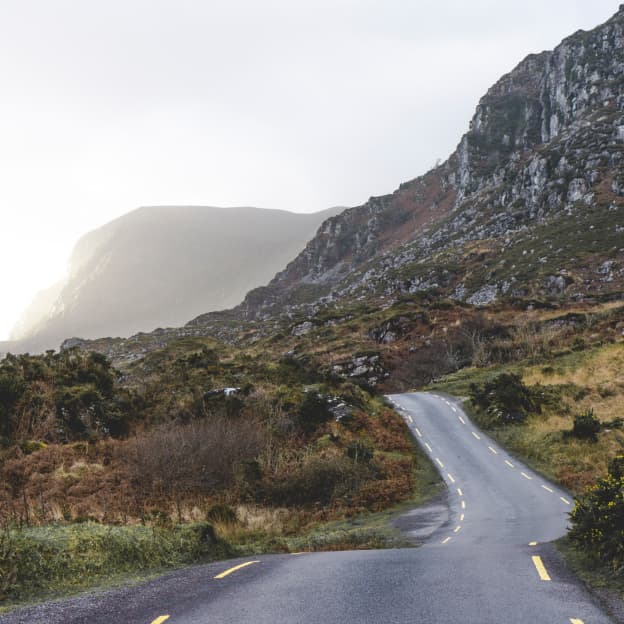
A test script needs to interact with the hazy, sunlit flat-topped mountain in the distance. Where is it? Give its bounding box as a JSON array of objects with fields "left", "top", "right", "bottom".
[{"left": 10, "top": 206, "right": 340, "bottom": 352}]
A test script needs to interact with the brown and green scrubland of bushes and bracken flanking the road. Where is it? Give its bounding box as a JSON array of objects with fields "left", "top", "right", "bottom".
[{"left": 0, "top": 293, "right": 624, "bottom": 600}]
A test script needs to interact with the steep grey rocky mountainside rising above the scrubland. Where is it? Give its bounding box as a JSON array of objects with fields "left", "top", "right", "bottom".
[{"left": 228, "top": 5, "right": 624, "bottom": 323}]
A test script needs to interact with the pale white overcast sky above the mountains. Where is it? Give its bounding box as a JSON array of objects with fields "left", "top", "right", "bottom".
[{"left": 0, "top": 0, "right": 618, "bottom": 339}]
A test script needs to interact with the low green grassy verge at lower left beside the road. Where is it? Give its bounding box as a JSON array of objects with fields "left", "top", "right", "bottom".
[{"left": 0, "top": 522, "right": 232, "bottom": 603}]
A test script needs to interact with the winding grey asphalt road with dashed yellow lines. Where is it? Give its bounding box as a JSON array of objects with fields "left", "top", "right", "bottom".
[{"left": 0, "top": 393, "right": 612, "bottom": 624}]
